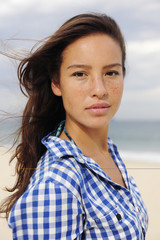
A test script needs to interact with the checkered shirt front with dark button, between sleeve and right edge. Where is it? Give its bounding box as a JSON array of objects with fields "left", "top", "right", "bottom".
[{"left": 79, "top": 171, "right": 147, "bottom": 239}]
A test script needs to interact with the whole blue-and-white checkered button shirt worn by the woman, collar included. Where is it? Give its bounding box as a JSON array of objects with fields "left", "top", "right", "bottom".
[{"left": 8, "top": 125, "right": 148, "bottom": 240}]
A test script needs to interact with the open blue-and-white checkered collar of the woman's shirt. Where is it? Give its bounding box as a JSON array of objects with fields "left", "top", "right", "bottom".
[{"left": 42, "top": 125, "right": 129, "bottom": 187}]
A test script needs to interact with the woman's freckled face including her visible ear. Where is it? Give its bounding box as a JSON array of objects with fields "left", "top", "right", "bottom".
[{"left": 52, "top": 34, "right": 123, "bottom": 129}]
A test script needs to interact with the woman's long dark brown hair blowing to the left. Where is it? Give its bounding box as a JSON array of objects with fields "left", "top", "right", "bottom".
[{"left": 0, "top": 14, "right": 126, "bottom": 217}]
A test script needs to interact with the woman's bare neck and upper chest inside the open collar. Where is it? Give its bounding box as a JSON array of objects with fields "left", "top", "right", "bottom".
[{"left": 60, "top": 121, "right": 126, "bottom": 187}]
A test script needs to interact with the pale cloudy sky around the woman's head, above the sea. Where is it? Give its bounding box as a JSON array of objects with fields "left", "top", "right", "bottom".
[{"left": 0, "top": 0, "right": 160, "bottom": 120}]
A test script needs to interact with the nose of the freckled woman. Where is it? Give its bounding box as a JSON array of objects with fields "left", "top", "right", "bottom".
[{"left": 91, "top": 76, "right": 107, "bottom": 99}]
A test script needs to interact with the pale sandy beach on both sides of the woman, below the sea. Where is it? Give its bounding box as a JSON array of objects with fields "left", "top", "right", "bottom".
[{"left": 0, "top": 150, "right": 160, "bottom": 240}]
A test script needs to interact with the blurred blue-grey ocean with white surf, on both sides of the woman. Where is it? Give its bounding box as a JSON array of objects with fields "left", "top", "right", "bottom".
[{"left": 0, "top": 118, "right": 160, "bottom": 162}]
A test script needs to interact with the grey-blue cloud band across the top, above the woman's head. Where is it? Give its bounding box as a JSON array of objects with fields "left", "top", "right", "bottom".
[{"left": 0, "top": 0, "right": 160, "bottom": 40}]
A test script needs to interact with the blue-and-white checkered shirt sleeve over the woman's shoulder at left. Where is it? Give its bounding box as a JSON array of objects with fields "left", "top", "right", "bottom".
[{"left": 9, "top": 180, "right": 83, "bottom": 240}]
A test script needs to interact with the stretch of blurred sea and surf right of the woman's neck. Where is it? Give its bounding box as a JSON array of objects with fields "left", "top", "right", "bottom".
[{"left": 109, "top": 121, "right": 160, "bottom": 162}]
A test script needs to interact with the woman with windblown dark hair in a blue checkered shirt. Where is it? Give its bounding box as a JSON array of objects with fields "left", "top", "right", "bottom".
[{"left": 1, "top": 14, "right": 148, "bottom": 240}]
